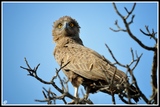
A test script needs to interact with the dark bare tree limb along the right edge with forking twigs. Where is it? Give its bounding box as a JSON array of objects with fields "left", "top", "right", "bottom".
[{"left": 109, "top": 3, "right": 158, "bottom": 104}]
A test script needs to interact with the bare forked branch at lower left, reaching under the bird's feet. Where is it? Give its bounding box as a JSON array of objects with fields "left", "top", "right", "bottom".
[{"left": 20, "top": 58, "right": 93, "bottom": 104}]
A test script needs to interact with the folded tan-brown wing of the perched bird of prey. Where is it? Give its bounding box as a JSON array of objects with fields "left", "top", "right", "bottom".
[{"left": 54, "top": 44, "right": 125, "bottom": 80}]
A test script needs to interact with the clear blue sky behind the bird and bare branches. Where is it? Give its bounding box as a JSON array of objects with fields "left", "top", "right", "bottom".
[{"left": 1, "top": 2, "right": 158, "bottom": 104}]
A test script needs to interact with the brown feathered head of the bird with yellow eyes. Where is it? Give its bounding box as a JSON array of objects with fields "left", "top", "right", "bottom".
[{"left": 52, "top": 16, "right": 80, "bottom": 41}]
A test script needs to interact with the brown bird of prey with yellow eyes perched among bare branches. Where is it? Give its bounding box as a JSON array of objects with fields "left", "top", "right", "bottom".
[{"left": 52, "top": 16, "right": 139, "bottom": 102}]
